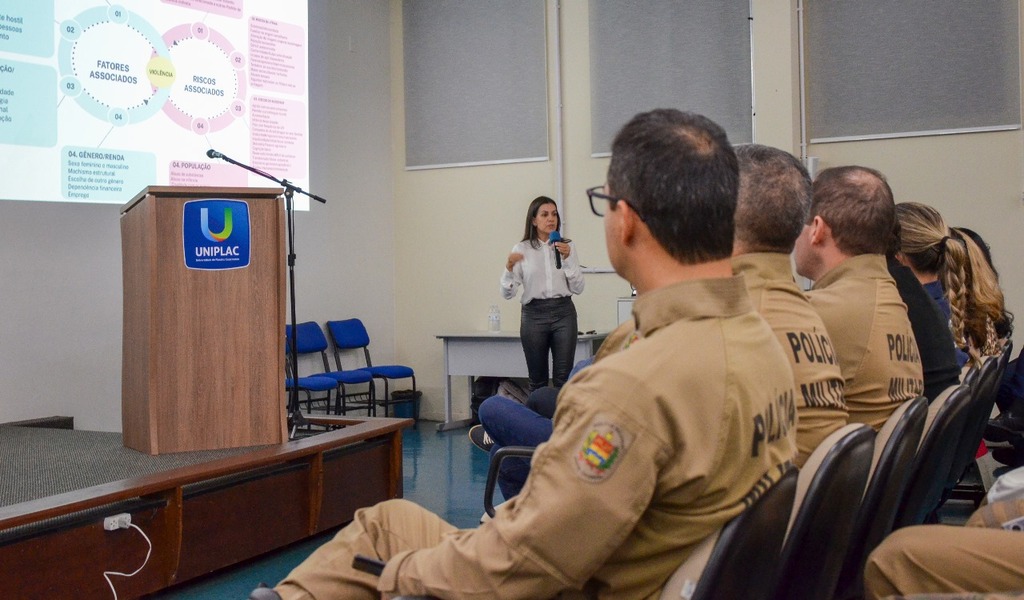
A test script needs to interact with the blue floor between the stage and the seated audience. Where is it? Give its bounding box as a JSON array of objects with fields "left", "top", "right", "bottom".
[{"left": 152, "top": 422, "right": 487, "bottom": 600}]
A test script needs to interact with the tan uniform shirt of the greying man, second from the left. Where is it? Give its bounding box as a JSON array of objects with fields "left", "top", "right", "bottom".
[{"left": 732, "top": 252, "right": 847, "bottom": 467}]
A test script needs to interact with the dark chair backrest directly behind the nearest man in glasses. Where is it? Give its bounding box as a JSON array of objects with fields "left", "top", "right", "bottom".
[{"left": 659, "top": 467, "right": 797, "bottom": 600}]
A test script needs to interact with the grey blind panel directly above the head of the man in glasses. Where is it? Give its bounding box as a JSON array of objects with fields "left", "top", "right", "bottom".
[{"left": 590, "top": 0, "right": 753, "bottom": 155}]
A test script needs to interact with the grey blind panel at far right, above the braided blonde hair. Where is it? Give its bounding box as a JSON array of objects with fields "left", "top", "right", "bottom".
[{"left": 804, "top": 0, "right": 1020, "bottom": 141}]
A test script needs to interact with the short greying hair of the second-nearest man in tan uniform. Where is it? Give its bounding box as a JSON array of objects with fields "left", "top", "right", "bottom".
[{"left": 735, "top": 143, "right": 811, "bottom": 254}]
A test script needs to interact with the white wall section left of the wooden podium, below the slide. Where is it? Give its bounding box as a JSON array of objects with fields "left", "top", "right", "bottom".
[{"left": 0, "top": 199, "right": 127, "bottom": 431}]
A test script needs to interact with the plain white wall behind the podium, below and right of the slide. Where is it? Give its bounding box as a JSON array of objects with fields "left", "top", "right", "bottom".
[{"left": 0, "top": 0, "right": 394, "bottom": 431}]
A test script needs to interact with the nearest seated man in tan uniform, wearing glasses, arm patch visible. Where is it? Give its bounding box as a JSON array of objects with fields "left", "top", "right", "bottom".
[{"left": 254, "top": 110, "right": 795, "bottom": 600}]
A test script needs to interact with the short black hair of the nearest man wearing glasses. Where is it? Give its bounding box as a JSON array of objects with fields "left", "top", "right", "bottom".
[{"left": 608, "top": 109, "right": 739, "bottom": 264}]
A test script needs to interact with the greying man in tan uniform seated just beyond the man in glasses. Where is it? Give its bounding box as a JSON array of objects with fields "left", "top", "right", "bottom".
[{"left": 732, "top": 143, "right": 847, "bottom": 467}]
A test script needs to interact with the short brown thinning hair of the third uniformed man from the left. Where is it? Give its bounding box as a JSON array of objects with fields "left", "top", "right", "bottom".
[{"left": 808, "top": 166, "right": 896, "bottom": 256}]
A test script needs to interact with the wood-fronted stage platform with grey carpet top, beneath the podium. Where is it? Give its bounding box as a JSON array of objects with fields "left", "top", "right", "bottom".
[{"left": 0, "top": 417, "right": 413, "bottom": 598}]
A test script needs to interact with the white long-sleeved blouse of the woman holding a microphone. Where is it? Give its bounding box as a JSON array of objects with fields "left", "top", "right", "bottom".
[{"left": 502, "top": 241, "right": 584, "bottom": 304}]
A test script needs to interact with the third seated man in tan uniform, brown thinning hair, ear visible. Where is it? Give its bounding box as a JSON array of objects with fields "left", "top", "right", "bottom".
[{"left": 796, "top": 167, "right": 924, "bottom": 430}]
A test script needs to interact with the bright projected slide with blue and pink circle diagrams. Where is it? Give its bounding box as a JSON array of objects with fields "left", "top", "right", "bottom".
[{"left": 0, "top": 0, "right": 309, "bottom": 208}]
